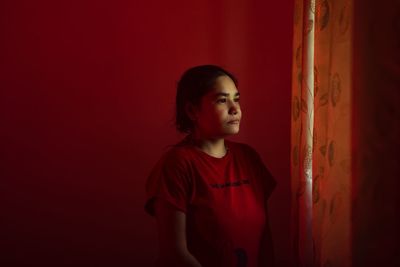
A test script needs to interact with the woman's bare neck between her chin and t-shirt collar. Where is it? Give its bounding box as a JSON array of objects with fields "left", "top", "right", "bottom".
[{"left": 190, "top": 134, "right": 227, "bottom": 158}]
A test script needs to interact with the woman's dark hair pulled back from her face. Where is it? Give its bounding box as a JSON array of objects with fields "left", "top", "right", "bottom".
[{"left": 175, "top": 65, "right": 237, "bottom": 133}]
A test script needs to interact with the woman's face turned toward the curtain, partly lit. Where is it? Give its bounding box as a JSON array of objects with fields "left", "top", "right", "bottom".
[{"left": 194, "top": 76, "right": 242, "bottom": 139}]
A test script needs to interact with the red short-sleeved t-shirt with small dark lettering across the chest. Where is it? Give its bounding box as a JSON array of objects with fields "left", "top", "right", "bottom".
[{"left": 145, "top": 140, "right": 275, "bottom": 267}]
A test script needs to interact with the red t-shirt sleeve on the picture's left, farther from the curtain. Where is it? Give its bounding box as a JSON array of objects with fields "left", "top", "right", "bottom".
[{"left": 145, "top": 153, "right": 192, "bottom": 216}]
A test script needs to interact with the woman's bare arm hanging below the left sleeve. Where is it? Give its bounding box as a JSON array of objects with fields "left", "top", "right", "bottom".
[{"left": 154, "top": 199, "right": 201, "bottom": 267}]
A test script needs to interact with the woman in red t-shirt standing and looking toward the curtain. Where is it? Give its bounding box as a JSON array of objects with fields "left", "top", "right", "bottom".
[{"left": 146, "top": 65, "right": 275, "bottom": 267}]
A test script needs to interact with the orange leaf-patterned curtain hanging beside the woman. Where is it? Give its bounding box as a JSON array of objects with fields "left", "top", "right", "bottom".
[{"left": 291, "top": 0, "right": 352, "bottom": 267}]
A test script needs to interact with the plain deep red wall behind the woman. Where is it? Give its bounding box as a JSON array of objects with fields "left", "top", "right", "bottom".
[{"left": 0, "top": 0, "right": 292, "bottom": 266}]
